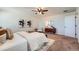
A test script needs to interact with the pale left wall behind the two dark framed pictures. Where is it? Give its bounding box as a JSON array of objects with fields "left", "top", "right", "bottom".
[{"left": 0, "top": 8, "right": 38, "bottom": 32}]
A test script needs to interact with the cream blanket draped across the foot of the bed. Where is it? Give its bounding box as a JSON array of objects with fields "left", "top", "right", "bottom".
[{"left": 17, "top": 31, "right": 48, "bottom": 51}]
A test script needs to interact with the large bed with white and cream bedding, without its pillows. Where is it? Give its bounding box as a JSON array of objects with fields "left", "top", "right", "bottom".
[{"left": 0, "top": 28, "right": 55, "bottom": 51}]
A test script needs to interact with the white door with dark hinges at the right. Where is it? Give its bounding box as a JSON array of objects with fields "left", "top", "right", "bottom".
[{"left": 65, "top": 15, "right": 75, "bottom": 37}]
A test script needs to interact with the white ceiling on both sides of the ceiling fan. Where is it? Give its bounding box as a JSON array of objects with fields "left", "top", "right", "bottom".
[{"left": 0, "top": 7, "right": 76, "bottom": 15}]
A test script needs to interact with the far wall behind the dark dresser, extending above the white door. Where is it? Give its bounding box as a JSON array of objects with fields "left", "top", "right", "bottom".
[{"left": 39, "top": 12, "right": 75, "bottom": 35}]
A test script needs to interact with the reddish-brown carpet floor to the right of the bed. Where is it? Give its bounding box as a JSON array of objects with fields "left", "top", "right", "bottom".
[{"left": 46, "top": 33, "right": 79, "bottom": 51}]
